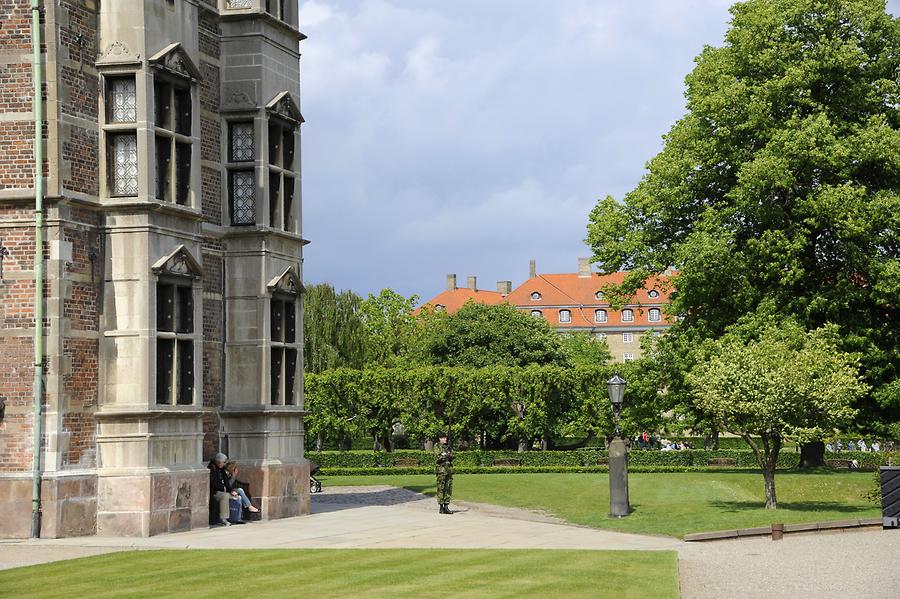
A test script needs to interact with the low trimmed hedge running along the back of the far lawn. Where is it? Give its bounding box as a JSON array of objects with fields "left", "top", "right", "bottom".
[{"left": 306, "top": 448, "right": 900, "bottom": 474}]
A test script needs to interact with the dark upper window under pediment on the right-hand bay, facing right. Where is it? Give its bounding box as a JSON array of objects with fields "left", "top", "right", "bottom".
[{"left": 269, "top": 118, "right": 297, "bottom": 231}]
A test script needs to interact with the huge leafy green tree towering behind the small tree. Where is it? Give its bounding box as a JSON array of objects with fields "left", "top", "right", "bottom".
[{"left": 587, "top": 0, "right": 900, "bottom": 432}]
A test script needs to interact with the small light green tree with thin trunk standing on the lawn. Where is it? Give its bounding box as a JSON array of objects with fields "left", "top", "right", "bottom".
[{"left": 687, "top": 322, "right": 868, "bottom": 509}]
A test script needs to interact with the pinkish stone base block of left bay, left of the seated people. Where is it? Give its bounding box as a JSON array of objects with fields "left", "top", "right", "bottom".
[{"left": 97, "top": 468, "right": 209, "bottom": 537}]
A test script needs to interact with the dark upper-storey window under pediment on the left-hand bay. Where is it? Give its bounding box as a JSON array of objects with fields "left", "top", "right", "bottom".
[{"left": 153, "top": 75, "right": 193, "bottom": 206}]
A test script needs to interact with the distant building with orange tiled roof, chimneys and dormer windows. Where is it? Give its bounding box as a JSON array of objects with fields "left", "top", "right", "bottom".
[{"left": 425, "top": 258, "right": 672, "bottom": 362}]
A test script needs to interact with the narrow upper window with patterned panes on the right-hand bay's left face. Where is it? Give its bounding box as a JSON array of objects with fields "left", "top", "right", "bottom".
[{"left": 228, "top": 121, "right": 256, "bottom": 226}]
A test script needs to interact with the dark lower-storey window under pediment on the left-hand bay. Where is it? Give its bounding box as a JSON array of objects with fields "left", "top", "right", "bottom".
[{"left": 156, "top": 281, "right": 194, "bottom": 405}]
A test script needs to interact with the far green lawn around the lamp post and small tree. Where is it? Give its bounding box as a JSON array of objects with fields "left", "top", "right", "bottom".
[{"left": 322, "top": 472, "right": 881, "bottom": 537}]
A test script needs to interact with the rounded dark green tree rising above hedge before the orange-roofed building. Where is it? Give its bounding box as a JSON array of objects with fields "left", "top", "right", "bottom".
[{"left": 421, "top": 301, "right": 566, "bottom": 368}]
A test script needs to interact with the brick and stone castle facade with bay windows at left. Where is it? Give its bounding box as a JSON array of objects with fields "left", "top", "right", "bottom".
[{"left": 0, "top": 0, "right": 309, "bottom": 537}]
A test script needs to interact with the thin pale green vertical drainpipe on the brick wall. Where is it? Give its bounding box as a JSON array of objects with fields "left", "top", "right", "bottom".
[{"left": 31, "top": 0, "right": 44, "bottom": 539}]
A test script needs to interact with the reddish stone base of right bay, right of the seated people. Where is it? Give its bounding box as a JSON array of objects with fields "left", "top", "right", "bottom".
[{"left": 239, "top": 459, "right": 312, "bottom": 520}]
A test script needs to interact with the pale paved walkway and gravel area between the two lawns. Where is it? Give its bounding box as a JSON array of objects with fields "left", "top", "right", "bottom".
[{"left": 0, "top": 487, "right": 900, "bottom": 599}]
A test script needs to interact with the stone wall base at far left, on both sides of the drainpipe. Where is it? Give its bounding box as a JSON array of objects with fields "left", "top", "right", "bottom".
[{"left": 0, "top": 473, "right": 97, "bottom": 539}]
